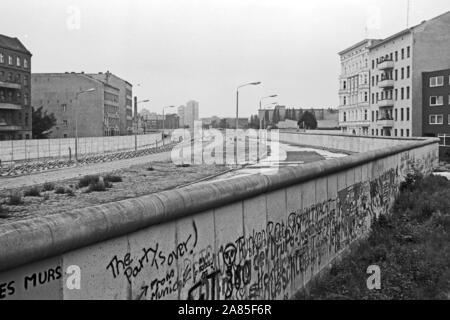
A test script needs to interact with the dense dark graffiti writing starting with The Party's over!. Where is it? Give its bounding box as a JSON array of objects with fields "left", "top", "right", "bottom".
[{"left": 106, "top": 169, "right": 399, "bottom": 300}]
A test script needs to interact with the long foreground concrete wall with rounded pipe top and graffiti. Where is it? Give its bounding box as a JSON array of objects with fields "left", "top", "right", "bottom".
[{"left": 0, "top": 133, "right": 438, "bottom": 299}]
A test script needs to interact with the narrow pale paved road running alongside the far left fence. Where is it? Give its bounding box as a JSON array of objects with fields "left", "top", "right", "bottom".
[{"left": 0, "top": 151, "right": 170, "bottom": 190}]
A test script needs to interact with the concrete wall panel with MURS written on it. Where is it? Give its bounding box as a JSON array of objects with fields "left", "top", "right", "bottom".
[{"left": 0, "top": 257, "right": 64, "bottom": 300}]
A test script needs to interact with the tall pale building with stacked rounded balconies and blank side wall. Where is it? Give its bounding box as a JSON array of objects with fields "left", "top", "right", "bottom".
[{"left": 340, "top": 12, "right": 450, "bottom": 137}]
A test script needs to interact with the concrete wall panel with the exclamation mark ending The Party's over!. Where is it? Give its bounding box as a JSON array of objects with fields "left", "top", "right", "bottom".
[{"left": 176, "top": 211, "right": 215, "bottom": 300}]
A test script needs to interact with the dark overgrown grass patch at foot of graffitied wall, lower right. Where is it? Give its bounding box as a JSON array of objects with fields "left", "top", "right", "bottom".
[{"left": 297, "top": 174, "right": 450, "bottom": 300}]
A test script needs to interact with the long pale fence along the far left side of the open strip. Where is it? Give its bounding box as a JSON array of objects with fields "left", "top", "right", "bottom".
[{"left": 0, "top": 133, "right": 162, "bottom": 165}]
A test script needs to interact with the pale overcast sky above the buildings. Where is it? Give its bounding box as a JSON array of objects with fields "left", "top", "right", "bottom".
[{"left": 0, "top": 0, "right": 450, "bottom": 117}]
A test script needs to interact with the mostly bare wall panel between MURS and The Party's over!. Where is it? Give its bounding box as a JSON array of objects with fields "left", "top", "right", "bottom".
[{"left": 63, "top": 237, "right": 131, "bottom": 300}]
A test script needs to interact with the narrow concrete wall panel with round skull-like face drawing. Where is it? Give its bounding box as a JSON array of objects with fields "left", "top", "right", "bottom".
[{"left": 214, "top": 202, "right": 245, "bottom": 300}]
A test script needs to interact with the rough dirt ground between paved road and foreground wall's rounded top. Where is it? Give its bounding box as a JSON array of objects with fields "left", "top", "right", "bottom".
[{"left": 0, "top": 162, "right": 228, "bottom": 224}]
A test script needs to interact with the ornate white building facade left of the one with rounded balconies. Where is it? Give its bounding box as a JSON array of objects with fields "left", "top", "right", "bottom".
[{"left": 339, "top": 39, "right": 377, "bottom": 135}]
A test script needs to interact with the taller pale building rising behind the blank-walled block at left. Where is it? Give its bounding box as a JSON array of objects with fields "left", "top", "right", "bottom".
[{"left": 89, "top": 71, "right": 133, "bottom": 135}]
